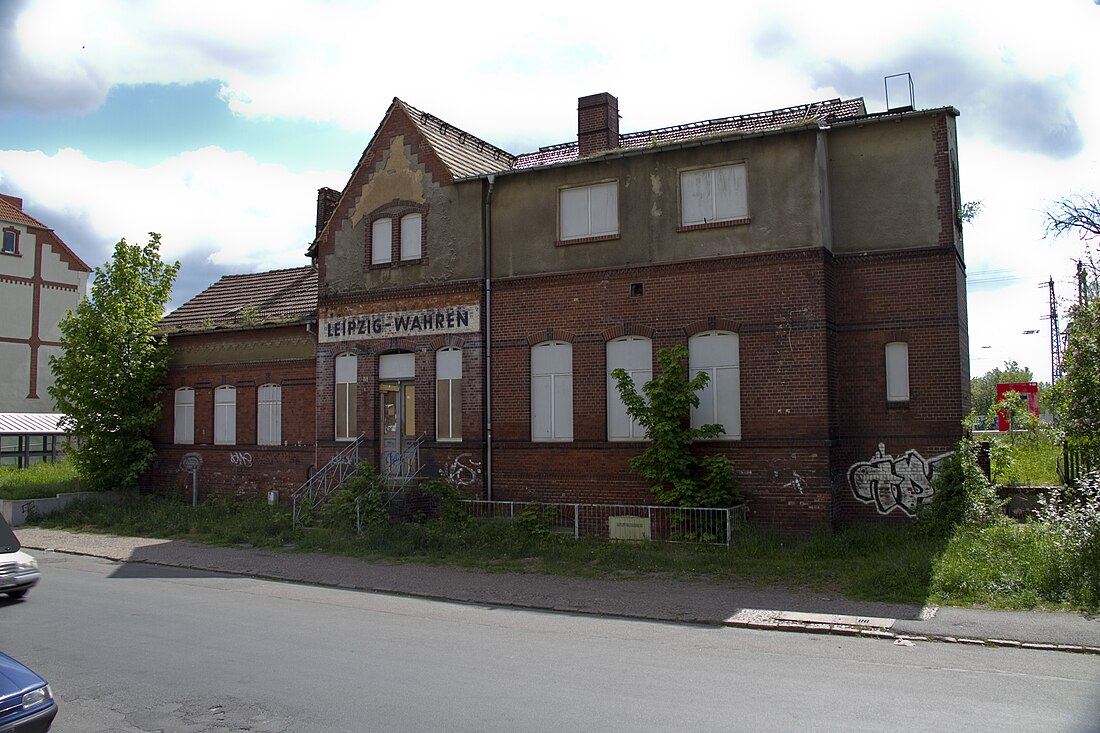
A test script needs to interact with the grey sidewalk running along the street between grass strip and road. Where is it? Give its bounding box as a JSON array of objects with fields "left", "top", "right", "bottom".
[{"left": 17, "top": 526, "right": 1100, "bottom": 655}]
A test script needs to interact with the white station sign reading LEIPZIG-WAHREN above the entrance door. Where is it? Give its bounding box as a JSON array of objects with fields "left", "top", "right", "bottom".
[{"left": 318, "top": 305, "right": 481, "bottom": 343}]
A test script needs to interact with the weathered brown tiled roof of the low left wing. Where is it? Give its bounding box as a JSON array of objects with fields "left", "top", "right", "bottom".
[{"left": 161, "top": 267, "right": 317, "bottom": 331}]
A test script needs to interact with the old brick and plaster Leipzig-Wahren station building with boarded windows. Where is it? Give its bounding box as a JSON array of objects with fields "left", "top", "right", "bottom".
[{"left": 150, "top": 94, "right": 969, "bottom": 530}]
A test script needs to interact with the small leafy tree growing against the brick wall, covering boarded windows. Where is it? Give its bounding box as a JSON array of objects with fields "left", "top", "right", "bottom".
[{"left": 612, "top": 346, "right": 736, "bottom": 506}]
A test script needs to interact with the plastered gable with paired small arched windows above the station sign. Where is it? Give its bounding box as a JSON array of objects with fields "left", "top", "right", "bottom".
[{"left": 309, "top": 98, "right": 516, "bottom": 299}]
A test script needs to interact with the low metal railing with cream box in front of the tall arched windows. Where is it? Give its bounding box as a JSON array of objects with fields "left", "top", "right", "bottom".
[{"left": 463, "top": 499, "right": 745, "bottom": 547}]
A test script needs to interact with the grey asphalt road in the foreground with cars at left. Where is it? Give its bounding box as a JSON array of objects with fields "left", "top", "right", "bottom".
[{"left": 0, "top": 551, "right": 1100, "bottom": 733}]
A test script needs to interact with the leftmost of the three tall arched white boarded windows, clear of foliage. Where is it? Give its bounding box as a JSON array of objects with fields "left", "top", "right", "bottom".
[{"left": 531, "top": 341, "right": 573, "bottom": 440}]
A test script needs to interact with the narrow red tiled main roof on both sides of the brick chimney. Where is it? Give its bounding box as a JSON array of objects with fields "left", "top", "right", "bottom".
[{"left": 514, "top": 97, "right": 867, "bottom": 169}]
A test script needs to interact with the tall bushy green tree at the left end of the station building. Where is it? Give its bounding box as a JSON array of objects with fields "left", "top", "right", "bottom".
[{"left": 50, "top": 232, "right": 179, "bottom": 490}]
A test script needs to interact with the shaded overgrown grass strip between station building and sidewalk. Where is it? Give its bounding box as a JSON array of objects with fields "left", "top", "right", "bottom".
[{"left": 34, "top": 496, "right": 959, "bottom": 604}]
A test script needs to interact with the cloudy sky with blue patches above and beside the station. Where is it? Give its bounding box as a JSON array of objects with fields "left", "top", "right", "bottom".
[{"left": 0, "top": 0, "right": 1100, "bottom": 381}]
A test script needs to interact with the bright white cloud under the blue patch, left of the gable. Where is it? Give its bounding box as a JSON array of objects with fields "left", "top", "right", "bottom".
[{"left": 0, "top": 147, "right": 338, "bottom": 272}]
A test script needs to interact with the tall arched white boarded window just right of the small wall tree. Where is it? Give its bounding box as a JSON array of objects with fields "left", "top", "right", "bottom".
[{"left": 688, "top": 331, "right": 741, "bottom": 440}]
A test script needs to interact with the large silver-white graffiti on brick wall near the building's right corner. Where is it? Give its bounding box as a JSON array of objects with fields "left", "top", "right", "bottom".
[{"left": 848, "top": 442, "right": 950, "bottom": 516}]
